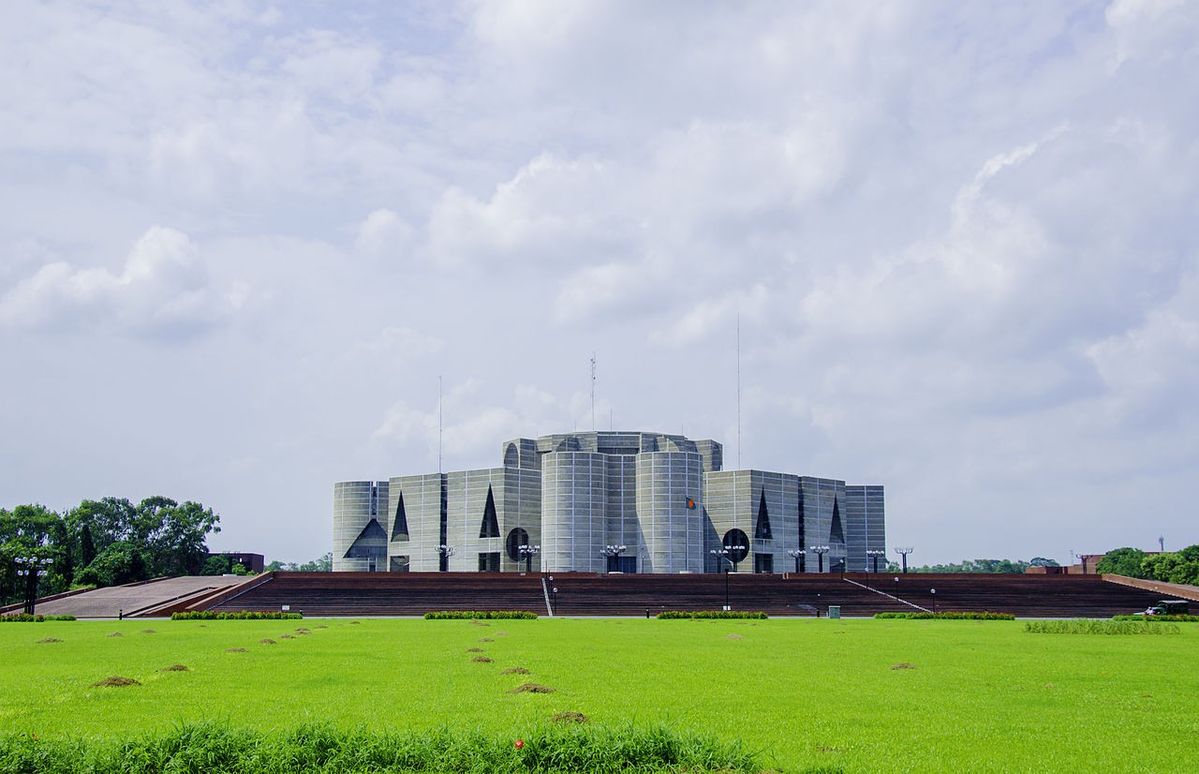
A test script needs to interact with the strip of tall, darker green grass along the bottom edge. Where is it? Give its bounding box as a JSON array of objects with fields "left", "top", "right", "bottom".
[{"left": 0, "top": 722, "right": 759, "bottom": 774}]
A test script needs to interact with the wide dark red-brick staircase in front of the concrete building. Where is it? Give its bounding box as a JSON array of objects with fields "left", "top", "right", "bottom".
[{"left": 177, "top": 573, "right": 1162, "bottom": 617}]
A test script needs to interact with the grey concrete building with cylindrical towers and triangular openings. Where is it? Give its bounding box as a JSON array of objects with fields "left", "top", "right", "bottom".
[{"left": 333, "top": 431, "right": 885, "bottom": 573}]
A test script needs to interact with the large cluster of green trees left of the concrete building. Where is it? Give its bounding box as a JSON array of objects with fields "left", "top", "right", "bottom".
[{"left": 0, "top": 496, "right": 221, "bottom": 604}]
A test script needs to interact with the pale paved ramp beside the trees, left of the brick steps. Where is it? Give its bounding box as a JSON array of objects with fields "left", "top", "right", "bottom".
[{"left": 25, "top": 575, "right": 248, "bottom": 618}]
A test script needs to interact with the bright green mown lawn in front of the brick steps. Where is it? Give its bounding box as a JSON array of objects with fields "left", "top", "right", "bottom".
[{"left": 0, "top": 618, "right": 1199, "bottom": 772}]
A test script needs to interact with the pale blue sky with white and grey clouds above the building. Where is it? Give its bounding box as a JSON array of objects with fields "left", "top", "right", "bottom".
[{"left": 0, "top": 0, "right": 1199, "bottom": 562}]
